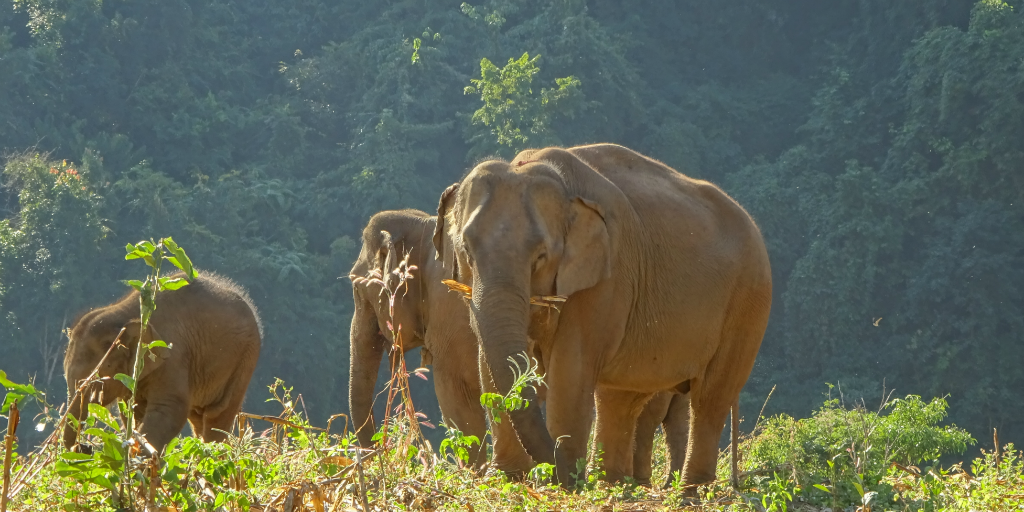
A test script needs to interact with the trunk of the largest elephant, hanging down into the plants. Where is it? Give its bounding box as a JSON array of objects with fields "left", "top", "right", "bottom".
[{"left": 471, "top": 279, "right": 555, "bottom": 464}]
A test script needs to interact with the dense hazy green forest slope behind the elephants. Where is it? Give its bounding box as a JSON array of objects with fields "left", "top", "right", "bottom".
[{"left": 0, "top": 0, "right": 1024, "bottom": 446}]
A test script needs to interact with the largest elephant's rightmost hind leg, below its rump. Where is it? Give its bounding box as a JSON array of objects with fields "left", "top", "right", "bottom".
[{"left": 683, "top": 291, "right": 771, "bottom": 484}]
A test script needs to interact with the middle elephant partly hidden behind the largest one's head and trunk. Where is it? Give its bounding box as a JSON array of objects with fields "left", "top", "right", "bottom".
[{"left": 348, "top": 210, "right": 532, "bottom": 473}]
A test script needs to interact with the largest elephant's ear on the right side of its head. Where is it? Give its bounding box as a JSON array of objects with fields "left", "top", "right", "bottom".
[{"left": 555, "top": 198, "right": 611, "bottom": 297}]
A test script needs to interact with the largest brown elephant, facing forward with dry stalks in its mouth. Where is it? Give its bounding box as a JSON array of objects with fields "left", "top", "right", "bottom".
[{"left": 433, "top": 144, "right": 771, "bottom": 485}]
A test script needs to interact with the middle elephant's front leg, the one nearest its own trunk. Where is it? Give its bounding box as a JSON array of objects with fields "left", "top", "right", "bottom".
[{"left": 433, "top": 352, "right": 487, "bottom": 466}]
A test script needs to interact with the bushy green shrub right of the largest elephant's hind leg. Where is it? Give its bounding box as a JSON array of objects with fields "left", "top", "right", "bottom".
[{"left": 744, "top": 395, "right": 975, "bottom": 510}]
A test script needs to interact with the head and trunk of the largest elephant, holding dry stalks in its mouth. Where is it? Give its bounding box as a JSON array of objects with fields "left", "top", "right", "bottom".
[{"left": 433, "top": 148, "right": 612, "bottom": 463}]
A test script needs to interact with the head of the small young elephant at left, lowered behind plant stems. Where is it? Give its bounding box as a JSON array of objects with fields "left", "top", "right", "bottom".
[{"left": 63, "top": 308, "right": 170, "bottom": 449}]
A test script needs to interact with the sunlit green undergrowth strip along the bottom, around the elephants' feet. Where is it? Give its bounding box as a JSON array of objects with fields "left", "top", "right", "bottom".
[{"left": 3, "top": 374, "right": 1024, "bottom": 512}]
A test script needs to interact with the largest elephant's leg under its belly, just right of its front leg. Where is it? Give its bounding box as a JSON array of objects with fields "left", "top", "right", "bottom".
[{"left": 595, "top": 387, "right": 656, "bottom": 481}]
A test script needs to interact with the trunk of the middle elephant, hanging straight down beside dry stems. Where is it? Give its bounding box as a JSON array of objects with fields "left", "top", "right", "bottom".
[{"left": 348, "top": 294, "right": 386, "bottom": 447}]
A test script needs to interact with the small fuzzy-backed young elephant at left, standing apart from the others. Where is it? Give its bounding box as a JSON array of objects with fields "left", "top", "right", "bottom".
[{"left": 63, "top": 271, "right": 263, "bottom": 452}]
